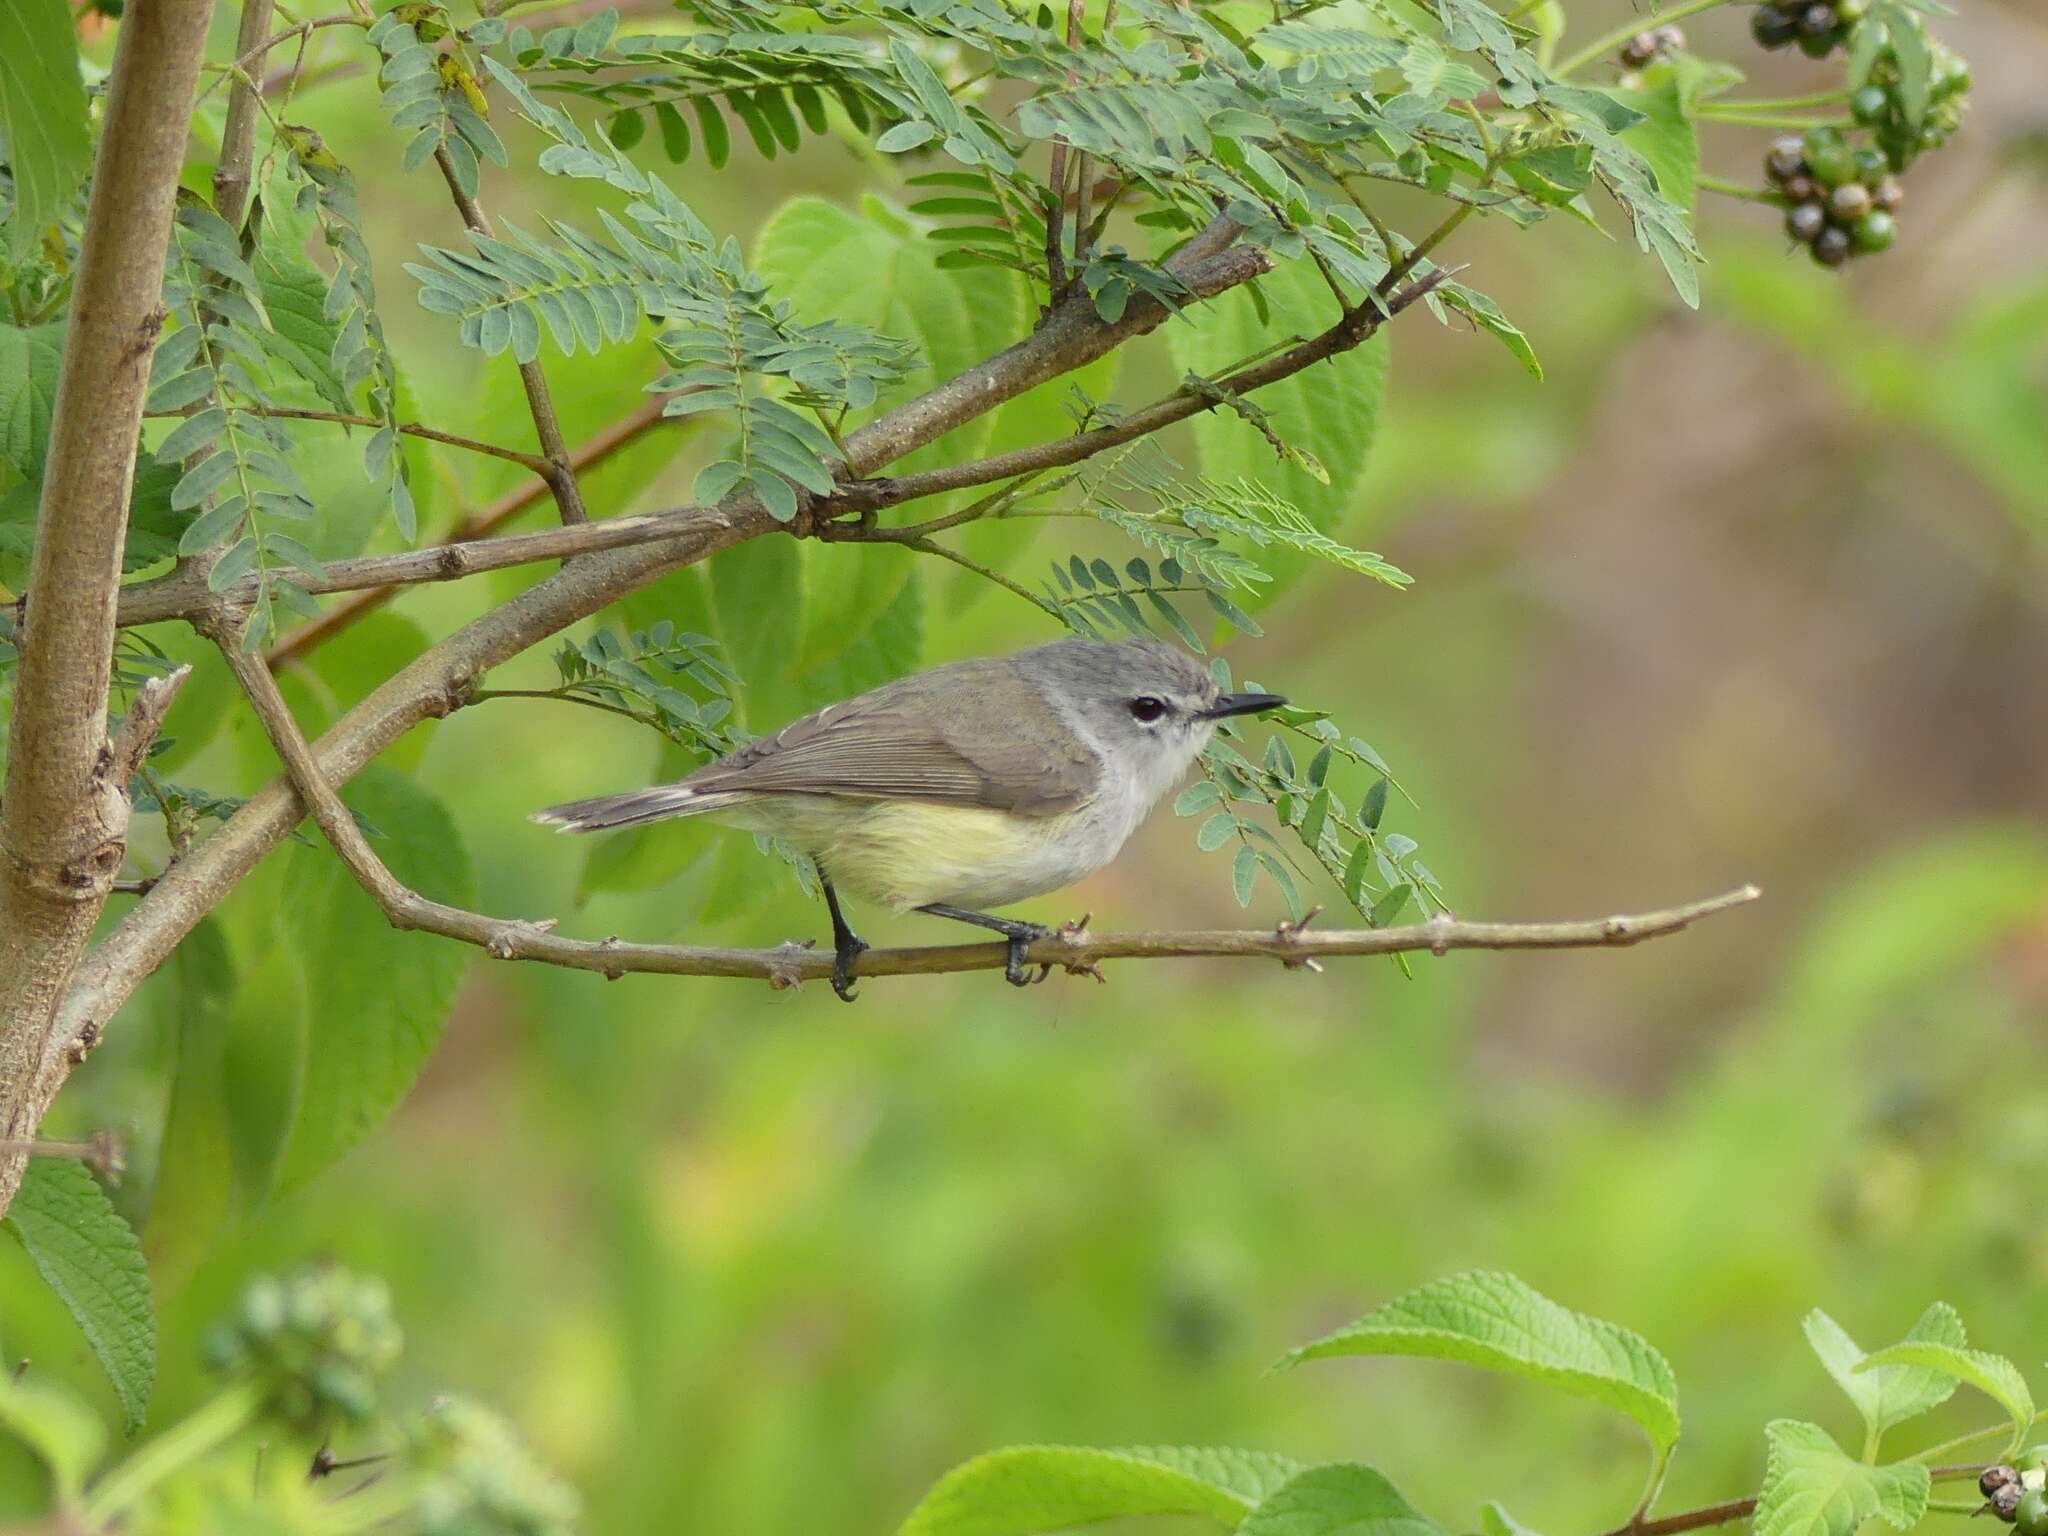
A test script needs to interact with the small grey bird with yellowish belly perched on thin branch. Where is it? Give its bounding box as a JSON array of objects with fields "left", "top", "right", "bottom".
[{"left": 532, "top": 639, "right": 1286, "bottom": 1001}]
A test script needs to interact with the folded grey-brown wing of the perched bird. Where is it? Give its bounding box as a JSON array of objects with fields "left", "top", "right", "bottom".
[{"left": 682, "top": 678, "right": 1096, "bottom": 815}]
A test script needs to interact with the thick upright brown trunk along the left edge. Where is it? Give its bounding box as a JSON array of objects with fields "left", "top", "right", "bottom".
[{"left": 0, "top": 0, "right": 213, "bottom": 1210}]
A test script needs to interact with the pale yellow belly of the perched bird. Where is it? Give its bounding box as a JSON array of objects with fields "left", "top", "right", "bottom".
[{"left": 725, "top": 795, "right": 1122, "bottom": 911}]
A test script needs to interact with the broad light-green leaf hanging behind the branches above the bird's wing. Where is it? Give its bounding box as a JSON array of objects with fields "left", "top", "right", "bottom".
[{"left": 754, "top": 197, "right": 999, "bottom": 672}]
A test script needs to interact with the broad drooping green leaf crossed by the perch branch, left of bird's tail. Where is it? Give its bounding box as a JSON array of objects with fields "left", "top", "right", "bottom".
[{"left": 276, "top": 766, "right": 475, "bottom": 1192}]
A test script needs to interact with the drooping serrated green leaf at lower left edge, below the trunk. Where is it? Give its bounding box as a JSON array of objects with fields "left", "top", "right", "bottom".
[{"left": 6, "top": 1157, "right": 156, "bottom": 1434}]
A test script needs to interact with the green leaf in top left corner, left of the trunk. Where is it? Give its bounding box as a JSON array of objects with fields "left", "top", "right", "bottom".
[{"left": 0, "top": 0, "right": 92, "bottom": 262}]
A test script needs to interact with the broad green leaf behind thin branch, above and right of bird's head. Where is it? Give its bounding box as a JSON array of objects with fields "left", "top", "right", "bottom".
[{"left": 1167, "top": 262, "right": 1389, "bottom": 602}]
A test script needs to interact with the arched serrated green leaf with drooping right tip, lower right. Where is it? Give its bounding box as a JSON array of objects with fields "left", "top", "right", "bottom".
[{"left": 1280, "top": 1270, "right": 1679, "bottom": 1454}]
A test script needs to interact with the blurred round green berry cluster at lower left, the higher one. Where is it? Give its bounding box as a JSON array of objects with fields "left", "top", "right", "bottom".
[{"left": 207, "top": 1268, "right": 403, "bottom": 1434}]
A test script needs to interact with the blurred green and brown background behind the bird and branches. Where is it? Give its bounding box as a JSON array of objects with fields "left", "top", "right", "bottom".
[{"left": 0, "top": 0, "right": 2048, "bottom": 1536}]
